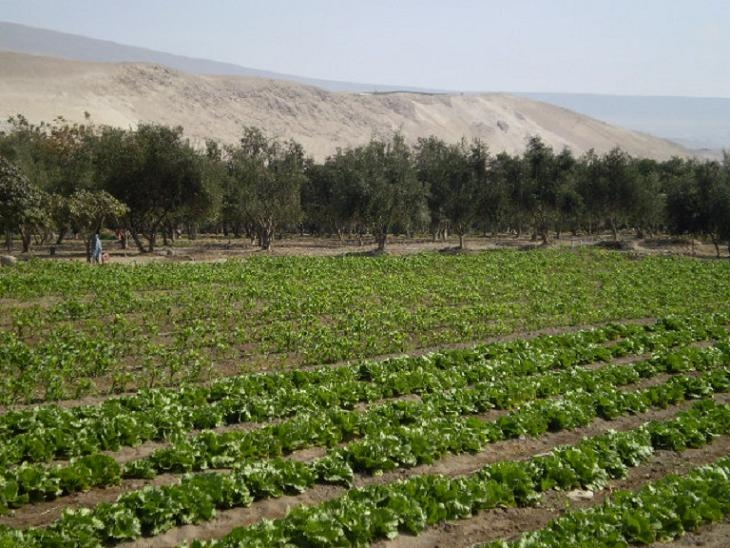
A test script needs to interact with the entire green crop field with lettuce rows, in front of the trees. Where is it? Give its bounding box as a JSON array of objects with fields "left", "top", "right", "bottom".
[{"left": 0, "top": 248, "right": 730, "bottom": 548}]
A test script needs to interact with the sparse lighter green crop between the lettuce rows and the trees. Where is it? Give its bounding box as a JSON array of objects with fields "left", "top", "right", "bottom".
[{"left": 0, "top": 249, "right": 730, "bottom": 402}]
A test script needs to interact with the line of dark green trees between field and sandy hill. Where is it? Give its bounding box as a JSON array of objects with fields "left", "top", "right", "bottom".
[{"left": 0, "top": 115, "right": 730, "bottom": 256}]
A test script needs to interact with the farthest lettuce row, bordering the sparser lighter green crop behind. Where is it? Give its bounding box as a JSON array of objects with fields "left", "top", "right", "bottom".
[{"left": 0, "top": 316, "right": 707, "bottom": 465}]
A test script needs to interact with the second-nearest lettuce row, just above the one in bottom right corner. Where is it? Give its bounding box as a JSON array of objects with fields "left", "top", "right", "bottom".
[{"left": 172, "top": 402, "right": 730, "bottom": 546}]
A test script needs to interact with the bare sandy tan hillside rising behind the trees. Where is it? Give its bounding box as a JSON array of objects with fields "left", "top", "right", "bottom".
[{"left": 0, "top": 52, "right": 688, "bottom": 159}]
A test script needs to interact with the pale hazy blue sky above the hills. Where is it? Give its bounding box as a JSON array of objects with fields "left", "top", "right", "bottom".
[{"left": 0, "top": 0, "right": 730, "bottom": 97}]
